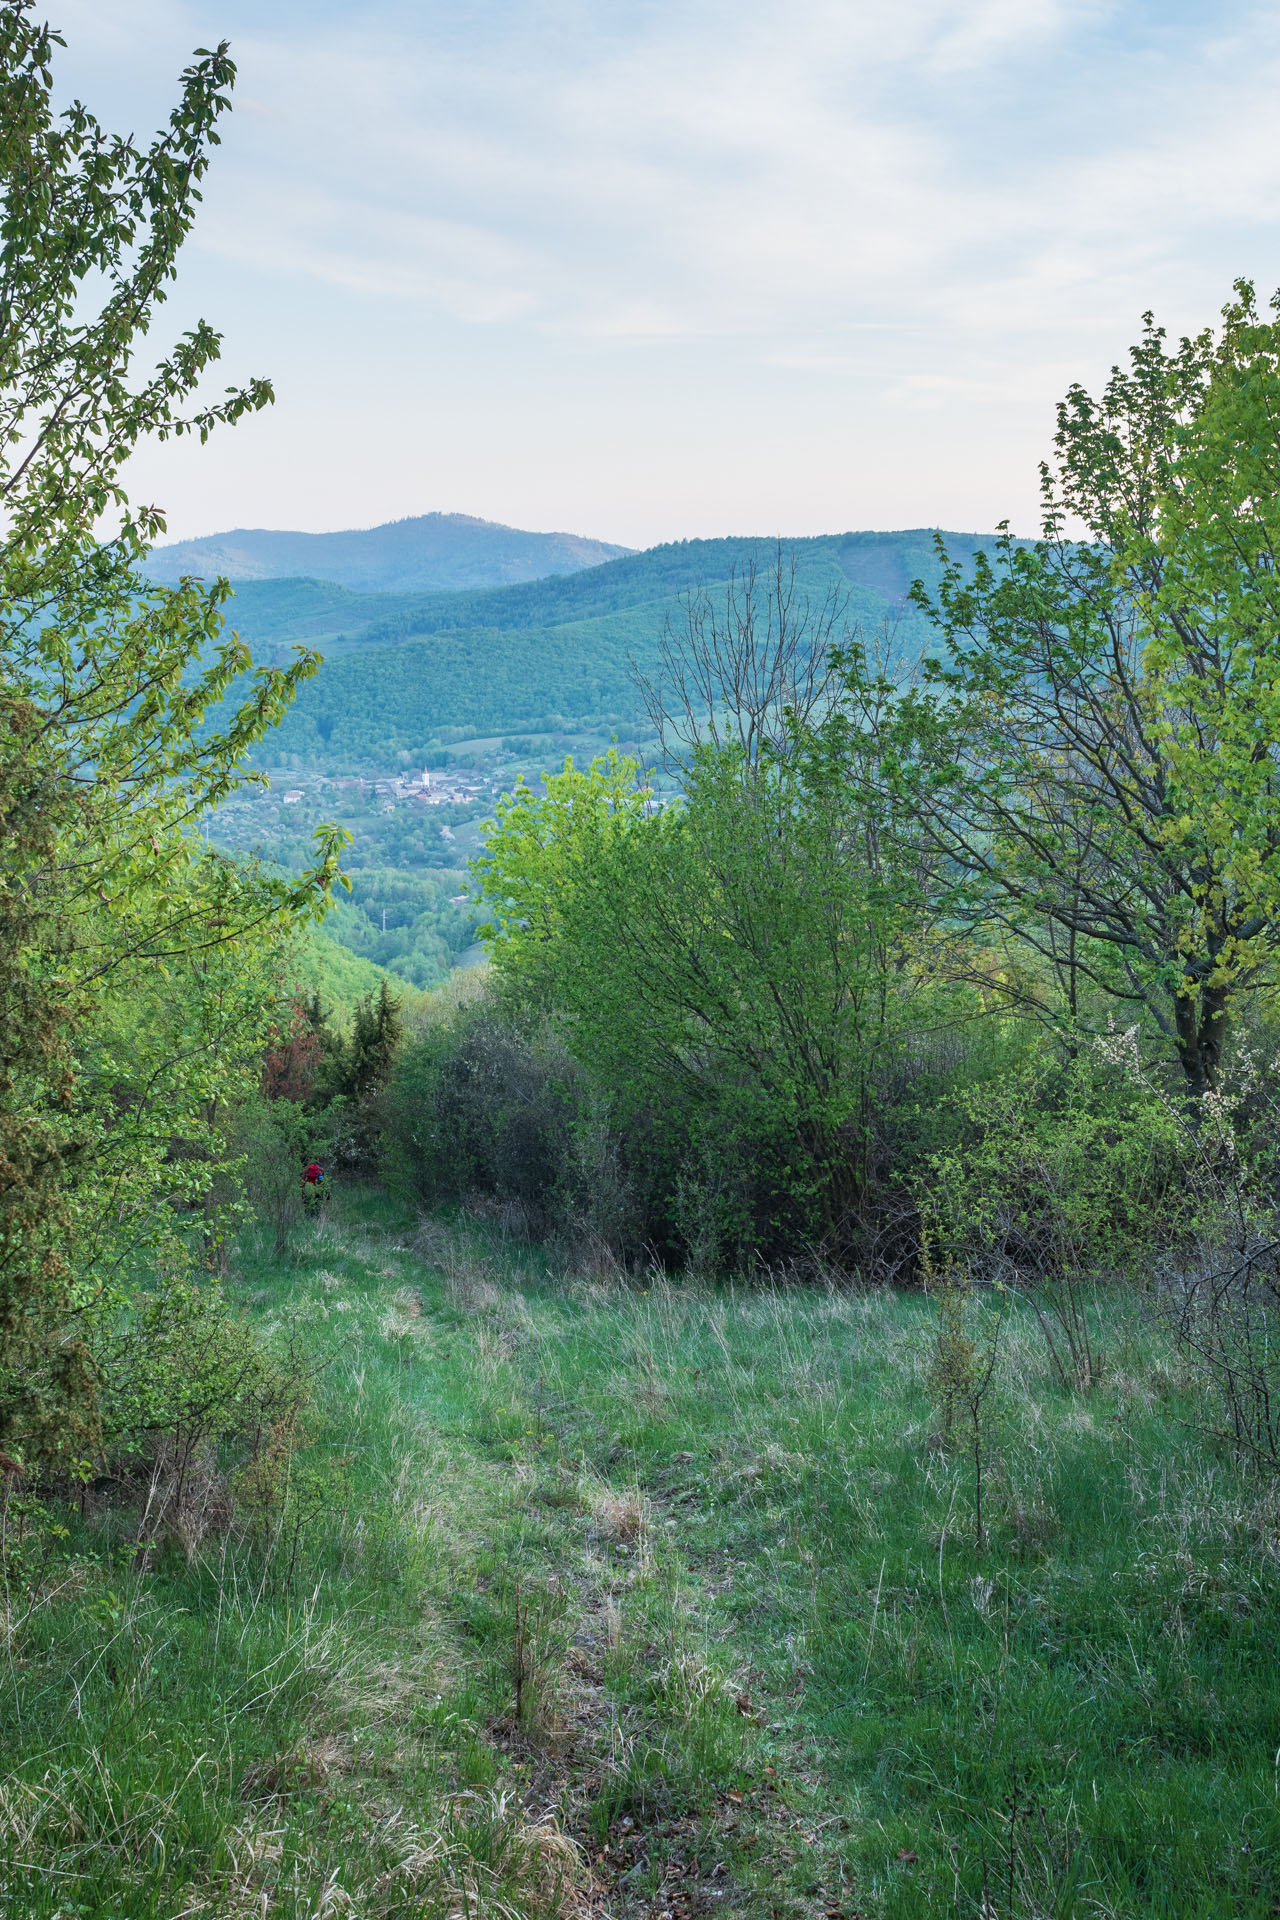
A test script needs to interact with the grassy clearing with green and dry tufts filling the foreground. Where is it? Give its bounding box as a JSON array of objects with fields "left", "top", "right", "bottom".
[{"left": 0, "top": 1194, "right": 1280, "bottom": 1920}]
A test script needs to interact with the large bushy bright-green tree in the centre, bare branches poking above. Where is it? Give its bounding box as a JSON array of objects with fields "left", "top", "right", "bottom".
[{"left": 478, "top": 652, "right": 936, "bottom": 1258}]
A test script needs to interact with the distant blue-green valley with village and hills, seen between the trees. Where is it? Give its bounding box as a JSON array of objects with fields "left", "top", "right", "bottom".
[{"left": 195, "top": 515, "right": 979, "bottom": 987}]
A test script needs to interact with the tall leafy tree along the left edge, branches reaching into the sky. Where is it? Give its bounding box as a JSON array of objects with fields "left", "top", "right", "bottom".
[{"left": 0, "top": 0, "right": 340, "bottom": 1452}]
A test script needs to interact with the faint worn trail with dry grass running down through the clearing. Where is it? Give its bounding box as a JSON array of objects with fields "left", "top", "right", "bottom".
[{"left": 370, "top": 1235, "right": 836, "bottom": 1920}]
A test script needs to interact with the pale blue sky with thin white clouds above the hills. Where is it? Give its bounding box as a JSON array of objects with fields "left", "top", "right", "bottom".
[{"left": 48, "top": 0, "right": 1280, "bottom": 545}]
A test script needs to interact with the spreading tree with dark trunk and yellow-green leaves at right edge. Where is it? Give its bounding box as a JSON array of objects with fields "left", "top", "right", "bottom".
[{"left": 902, "top": 282, "right": 1280, "bottom": 1100}]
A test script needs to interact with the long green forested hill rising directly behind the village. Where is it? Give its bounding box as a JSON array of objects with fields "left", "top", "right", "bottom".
[{"left": 214, "top": 528, "right": 992, "bottom": 766}]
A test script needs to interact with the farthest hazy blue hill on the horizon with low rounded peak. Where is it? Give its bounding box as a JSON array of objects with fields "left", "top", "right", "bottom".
[{"left": 148, "top": 513, "right": 629, "bottom": 593}]
